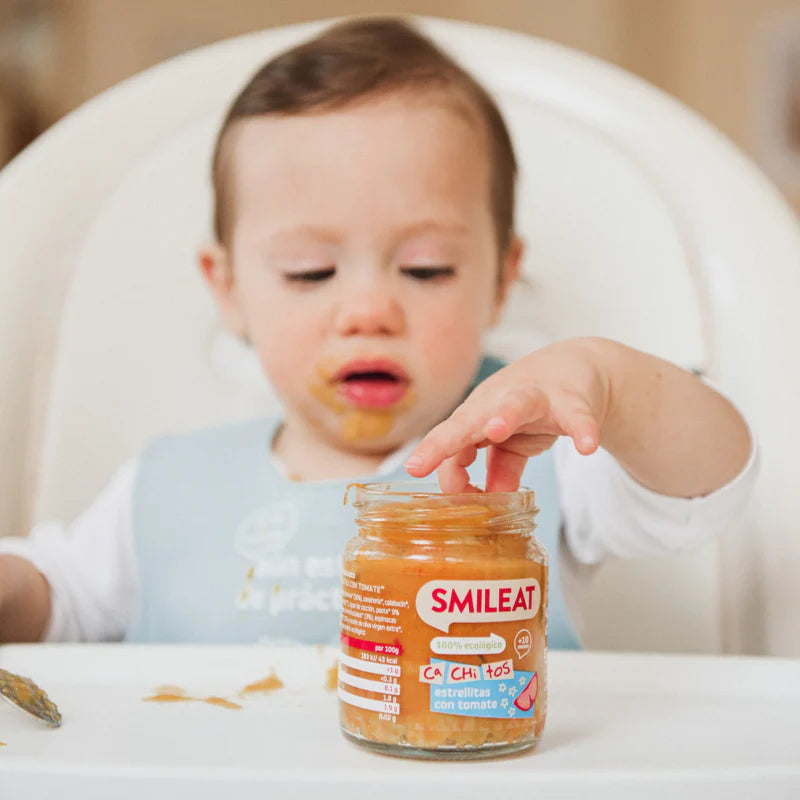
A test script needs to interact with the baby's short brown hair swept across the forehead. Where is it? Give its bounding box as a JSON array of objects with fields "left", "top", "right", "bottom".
[{"left": 212, "top": 18, "right": 517, "bottom": 252}]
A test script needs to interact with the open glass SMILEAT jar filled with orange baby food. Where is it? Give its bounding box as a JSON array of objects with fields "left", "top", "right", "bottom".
[{"left": 338, "top": 483, "right": 548, "bottom": 759}]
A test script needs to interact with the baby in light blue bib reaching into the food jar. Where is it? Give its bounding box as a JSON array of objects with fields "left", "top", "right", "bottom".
[{"left": 0, "top": 15, "right": 756, "bottom": 647}]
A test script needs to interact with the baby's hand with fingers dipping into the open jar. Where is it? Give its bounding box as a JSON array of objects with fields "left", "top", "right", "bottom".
[{"left": 406, "top": 339, "right": 609, "bottom": 493}]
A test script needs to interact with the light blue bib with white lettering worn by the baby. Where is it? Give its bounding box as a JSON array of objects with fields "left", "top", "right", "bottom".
[{"left": 127, "top": 359, "right": 580, "bottom": 649}]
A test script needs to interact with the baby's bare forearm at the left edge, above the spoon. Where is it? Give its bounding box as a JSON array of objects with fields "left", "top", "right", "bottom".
[{"left": 0, "top": 554, "right": 50, "bottom": 644}]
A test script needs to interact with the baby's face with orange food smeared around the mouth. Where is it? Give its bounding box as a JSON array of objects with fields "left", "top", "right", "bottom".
[{"left": 201, "top": 94, "right": 516, "bottom": 454}]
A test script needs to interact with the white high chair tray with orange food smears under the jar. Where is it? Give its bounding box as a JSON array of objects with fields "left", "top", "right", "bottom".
[{"left": 0, "top": 645, "right": 800, "bottom": 800}]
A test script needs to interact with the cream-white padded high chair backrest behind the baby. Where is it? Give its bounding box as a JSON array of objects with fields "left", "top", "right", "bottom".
[{"left": 0, "top": 19, "right": 800, "bottom": 656}]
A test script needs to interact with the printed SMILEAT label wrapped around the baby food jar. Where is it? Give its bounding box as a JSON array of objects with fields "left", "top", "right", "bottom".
[{"left": 338, "top": 565, "right": 546, "bottom": 735}]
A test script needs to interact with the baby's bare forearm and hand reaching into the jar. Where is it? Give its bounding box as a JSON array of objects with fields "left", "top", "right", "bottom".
[{"left": 406, "top": 338, "right": 750, "bottom": 497}]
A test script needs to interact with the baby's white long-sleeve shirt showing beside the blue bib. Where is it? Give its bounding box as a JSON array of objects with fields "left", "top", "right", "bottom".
[{"left": 0, "top": 436, "right": 758, "bottom": 641}]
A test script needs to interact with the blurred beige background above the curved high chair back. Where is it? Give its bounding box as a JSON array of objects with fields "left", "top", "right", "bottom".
[{"left": 0, "top": 0, "right": 800, "bottom": 216}]
